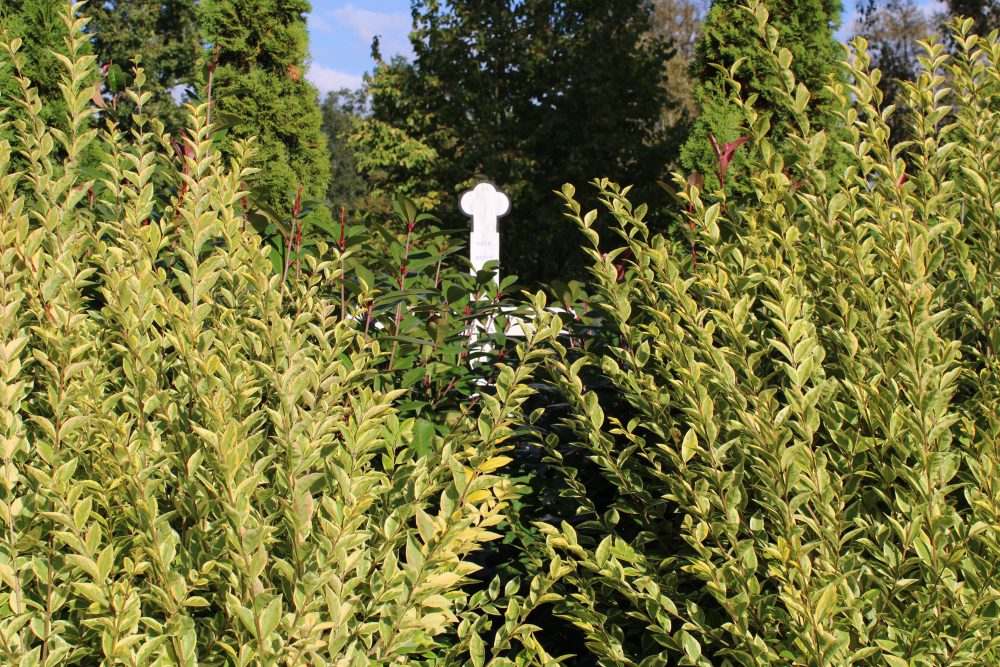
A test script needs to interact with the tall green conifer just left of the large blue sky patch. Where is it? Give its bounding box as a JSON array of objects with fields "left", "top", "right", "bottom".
[{"left": 198, "top": 0, "right": 330, "bottom": 221}]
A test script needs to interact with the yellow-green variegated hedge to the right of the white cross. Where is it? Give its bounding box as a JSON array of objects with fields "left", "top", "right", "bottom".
[{"left": 539, "top": 2, "right": 1000, "bottom": 667}]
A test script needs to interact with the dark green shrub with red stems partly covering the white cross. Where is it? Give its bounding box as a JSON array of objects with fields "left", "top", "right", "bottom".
[{"left": 356, "top": 197, "right": 527, "bottom": 423}]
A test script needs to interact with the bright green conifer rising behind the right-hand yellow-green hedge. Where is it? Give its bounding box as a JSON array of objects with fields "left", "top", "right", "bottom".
[{"left": 681, "top": 0, "right": 843, "bottom": 194}]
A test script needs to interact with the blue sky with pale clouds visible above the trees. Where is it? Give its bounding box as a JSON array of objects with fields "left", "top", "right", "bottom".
[{"left": 308, "top": 0, "right": 941, "bottom": 93}]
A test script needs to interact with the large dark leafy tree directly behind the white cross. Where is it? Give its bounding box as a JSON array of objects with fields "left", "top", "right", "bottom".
[{"left": 357, "top": 0, "right": 669, "bottom": 281}]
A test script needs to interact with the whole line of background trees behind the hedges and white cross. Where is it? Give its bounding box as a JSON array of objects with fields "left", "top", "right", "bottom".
[{"left": 0, "top": 0, "right": 998, "bottom": 284}]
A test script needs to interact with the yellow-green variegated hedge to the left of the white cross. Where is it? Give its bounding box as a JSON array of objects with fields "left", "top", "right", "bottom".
[{"left": 0, "top": 3, "right": 560, "bottom": 667}]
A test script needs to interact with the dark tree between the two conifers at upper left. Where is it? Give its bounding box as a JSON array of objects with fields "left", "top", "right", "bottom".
[{"left": 86, "top": 0, "right": 201, "bottom": 140}]
